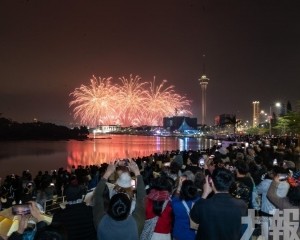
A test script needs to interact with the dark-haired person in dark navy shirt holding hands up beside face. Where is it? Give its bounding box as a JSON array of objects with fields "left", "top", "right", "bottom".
[{"left": 190, "top": 168, "right": 248, "bottom": 240}]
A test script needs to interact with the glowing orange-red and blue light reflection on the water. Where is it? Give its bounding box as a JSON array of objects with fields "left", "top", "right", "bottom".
[{"left": 67, "top": 135, "right": 215, "bottom": 167}]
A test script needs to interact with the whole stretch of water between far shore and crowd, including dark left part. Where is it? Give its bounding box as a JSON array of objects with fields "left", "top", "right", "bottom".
[{"left": 0, "top": 135, "right": 215, "bottom": 179}]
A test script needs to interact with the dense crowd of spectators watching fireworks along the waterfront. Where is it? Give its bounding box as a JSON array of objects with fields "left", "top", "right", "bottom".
[{"left": 0, "top": 141, "right": 300, "bottom": 240}]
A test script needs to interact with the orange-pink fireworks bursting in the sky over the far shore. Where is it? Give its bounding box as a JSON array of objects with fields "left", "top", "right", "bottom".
[{"left": 70, "top": 75, "right": 191, "bottom": 126}]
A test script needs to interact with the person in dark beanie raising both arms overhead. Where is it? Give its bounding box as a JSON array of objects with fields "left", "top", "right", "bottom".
[{"left": 93, "top": 160, "right": 146, "bottom": 240}]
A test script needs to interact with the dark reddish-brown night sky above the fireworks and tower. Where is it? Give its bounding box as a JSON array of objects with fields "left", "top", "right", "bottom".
[{"left": 0, "top": 0, "right": 300, "bottom": 126}]
